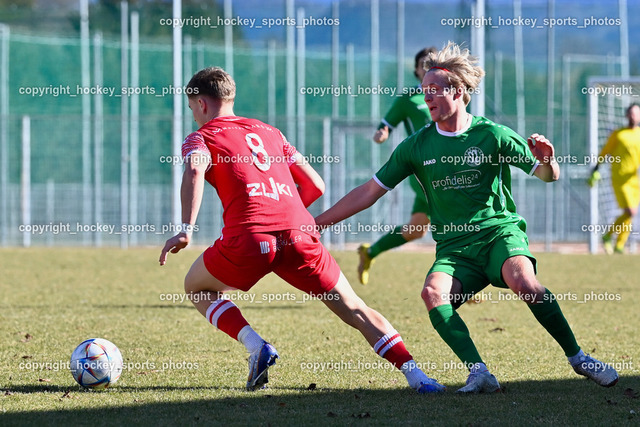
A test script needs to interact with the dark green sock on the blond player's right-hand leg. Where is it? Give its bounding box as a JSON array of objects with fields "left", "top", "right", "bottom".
[{"left": 527, "top": 289, "right": 580, "bottom": 357}]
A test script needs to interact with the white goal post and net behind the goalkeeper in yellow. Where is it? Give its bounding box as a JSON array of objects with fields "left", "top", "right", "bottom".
[{"left": 585, "top": 76, "right": 640, "bottom": 254}]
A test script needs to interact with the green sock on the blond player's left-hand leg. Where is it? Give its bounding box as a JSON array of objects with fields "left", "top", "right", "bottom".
[{"left": 429, "top": 304, "right": 482, "bottom": 366}]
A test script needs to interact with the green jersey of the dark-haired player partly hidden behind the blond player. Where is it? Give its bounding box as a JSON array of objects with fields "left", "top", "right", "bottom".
[{"left": 379, "top": 87, "right": 431, "bottom": 135}]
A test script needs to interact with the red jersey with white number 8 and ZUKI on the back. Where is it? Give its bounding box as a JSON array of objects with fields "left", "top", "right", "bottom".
[{"left": 182, "top": 116, "right": 315, "bottom": 236}]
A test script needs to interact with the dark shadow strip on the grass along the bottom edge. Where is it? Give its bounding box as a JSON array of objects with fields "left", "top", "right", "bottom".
[{"left": 0, "top": 376, "right": 640, "bottom": 425}]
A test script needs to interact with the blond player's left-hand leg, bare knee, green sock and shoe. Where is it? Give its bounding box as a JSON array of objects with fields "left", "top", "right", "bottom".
[{"left": 422, "top": 272, "right": 500, "bottom": 394}]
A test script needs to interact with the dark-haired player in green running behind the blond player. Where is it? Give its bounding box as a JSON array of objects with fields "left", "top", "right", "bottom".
[{"left": 358, "top": 47, "right": 436, "bottom": 285}]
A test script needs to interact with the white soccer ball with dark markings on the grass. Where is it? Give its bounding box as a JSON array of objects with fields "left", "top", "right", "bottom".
[{"left": 70, "top": 338, "right": 123, "bottom": 389}]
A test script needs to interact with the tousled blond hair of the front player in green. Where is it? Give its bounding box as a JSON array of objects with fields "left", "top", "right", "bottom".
[{"left": 424, "top": 41, "right": 485, "bottom": 105}]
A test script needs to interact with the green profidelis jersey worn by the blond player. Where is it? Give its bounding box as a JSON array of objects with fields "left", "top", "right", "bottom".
[{"left": 374, "top": 116, "right": 539, "bottom": 243}]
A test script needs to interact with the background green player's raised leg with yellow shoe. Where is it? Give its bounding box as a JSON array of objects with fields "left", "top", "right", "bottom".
[{"left": 358, "top": 212, "right": 429, "bottom": 285}]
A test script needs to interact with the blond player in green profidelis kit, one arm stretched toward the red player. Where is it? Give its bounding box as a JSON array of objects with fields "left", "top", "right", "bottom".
[{"left": 316, "top": 42, "right": 618, "bottom": 393}]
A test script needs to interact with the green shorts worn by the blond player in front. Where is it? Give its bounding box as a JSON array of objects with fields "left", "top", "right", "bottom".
[{"left": 429, "top": 224, "right": 537, "bottom": 302}]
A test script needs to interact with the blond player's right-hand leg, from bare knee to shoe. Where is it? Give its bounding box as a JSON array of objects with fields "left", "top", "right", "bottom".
[{"left": 502, "top": 255, "right": 618, "bottom": 387}]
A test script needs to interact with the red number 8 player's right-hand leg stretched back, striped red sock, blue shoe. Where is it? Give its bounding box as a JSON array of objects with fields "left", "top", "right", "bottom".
[{"left": 323, "top": 273, "right": 445, "bottom": 393}]
